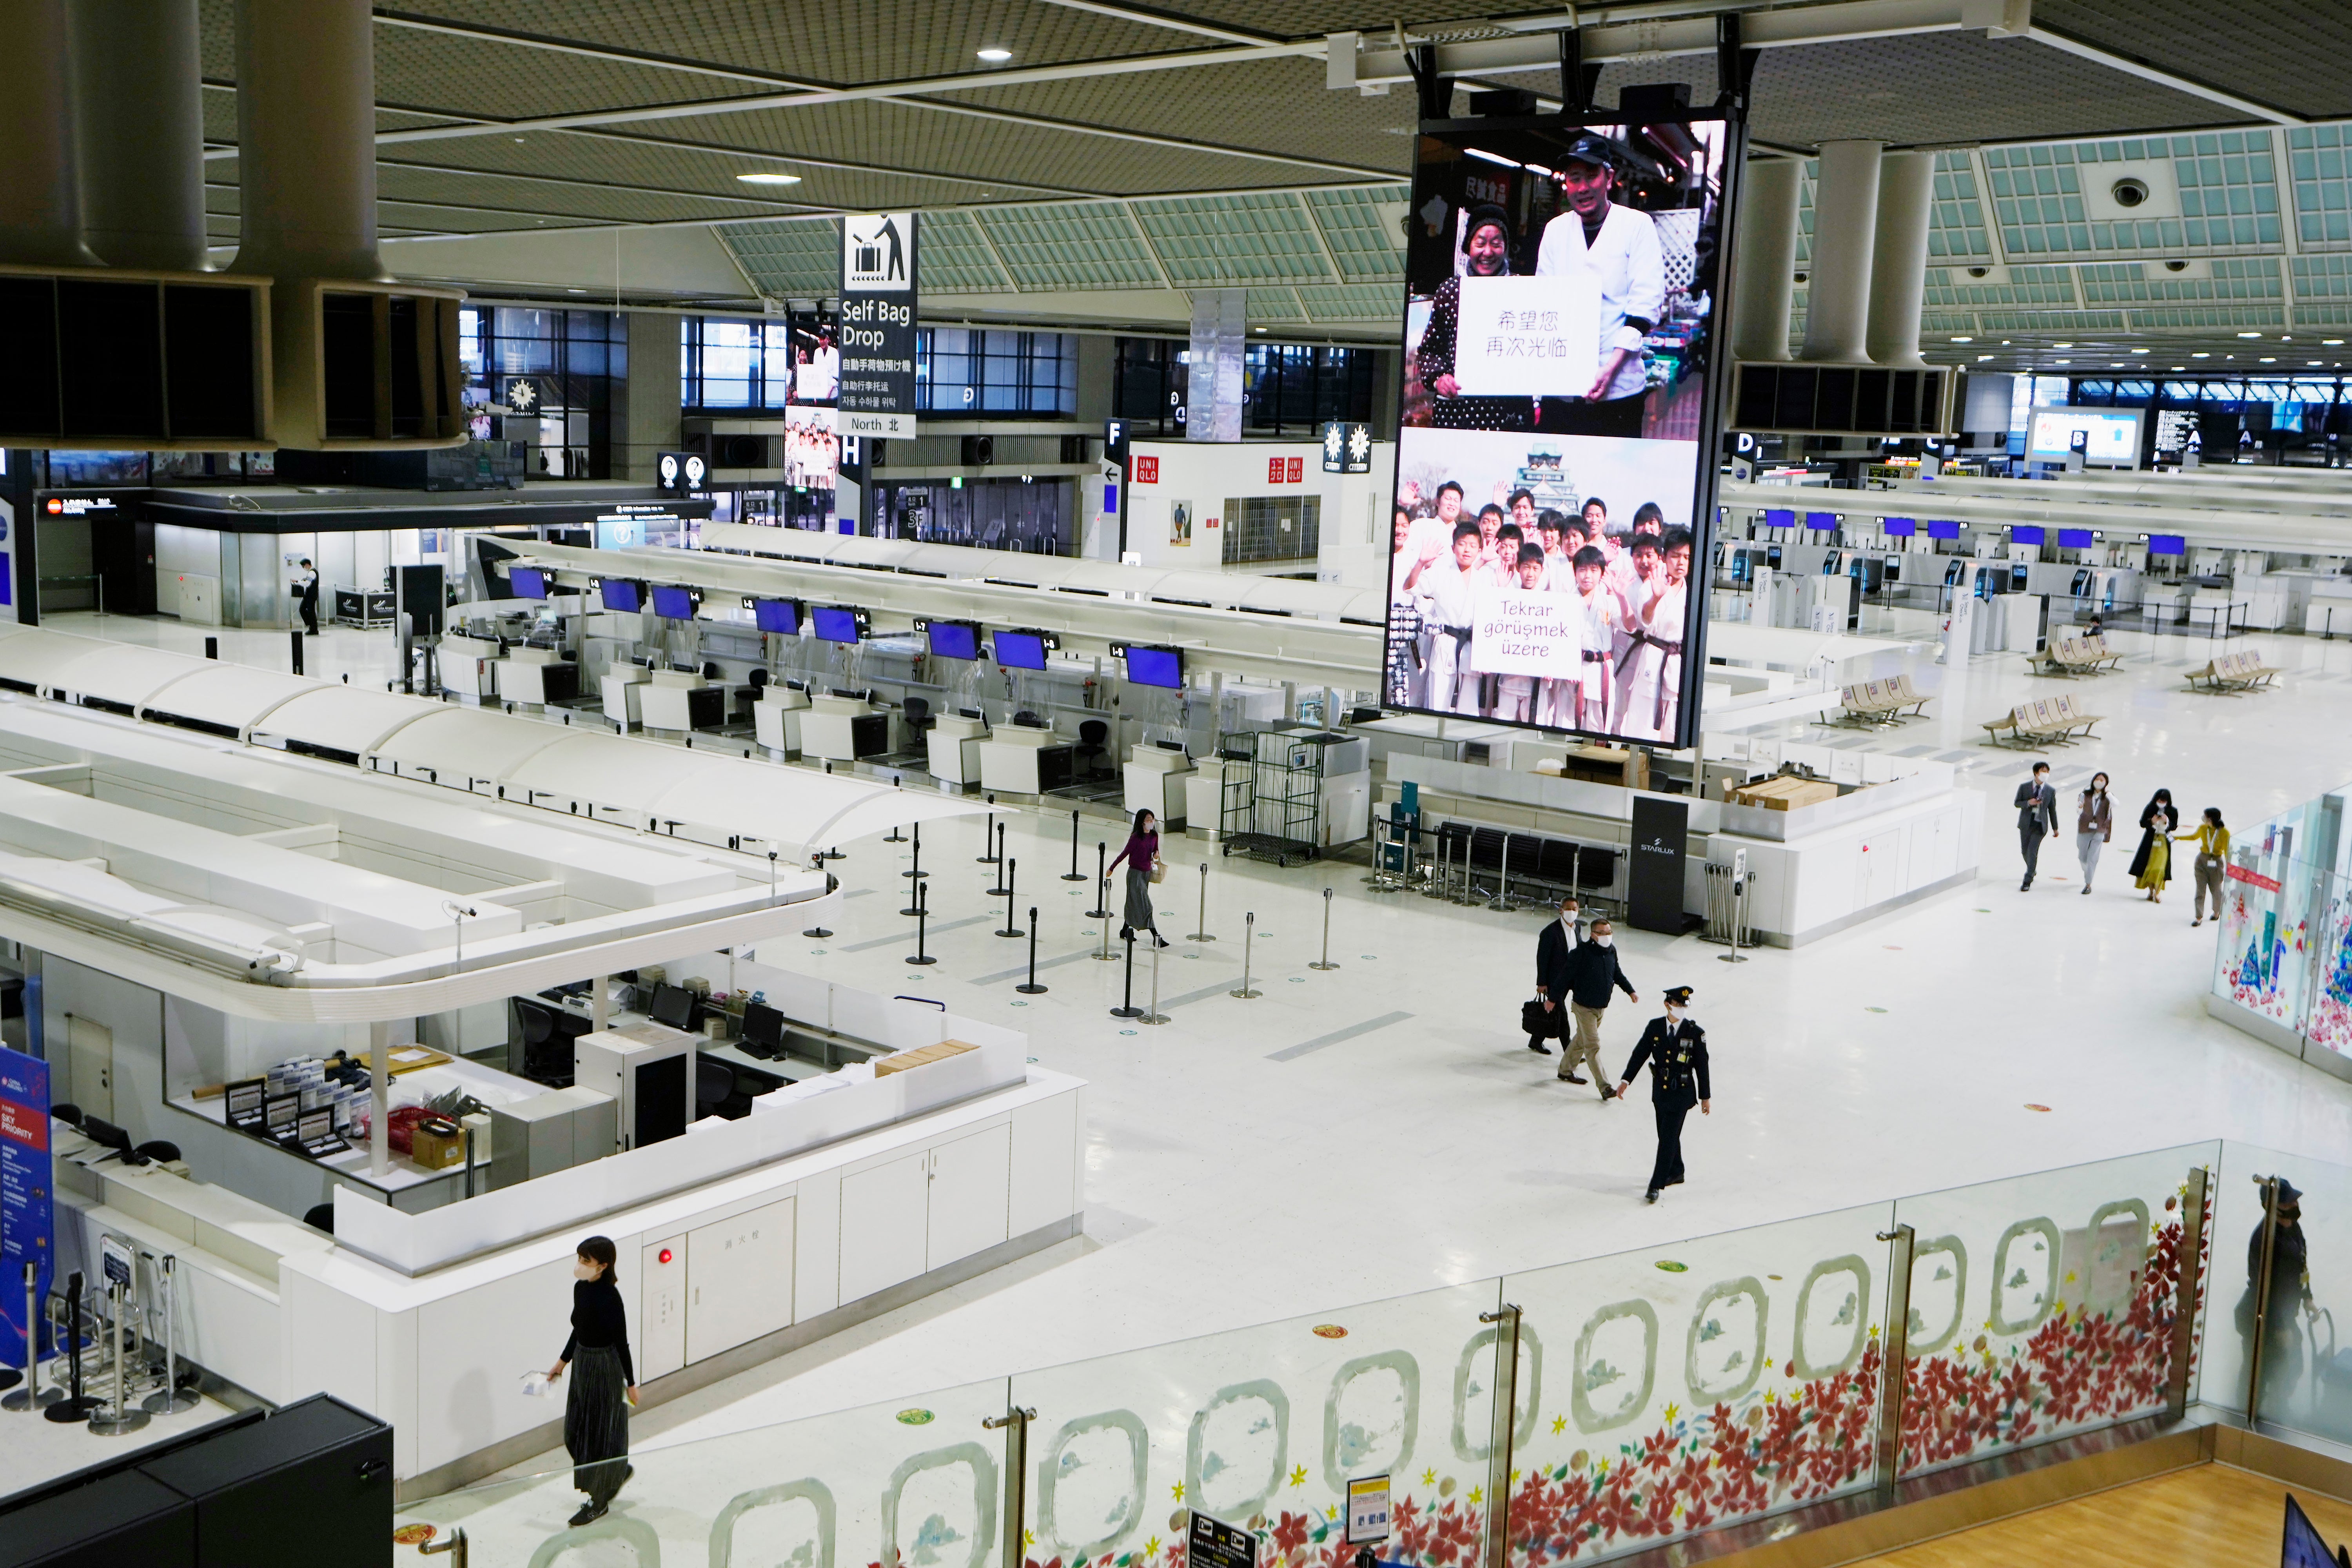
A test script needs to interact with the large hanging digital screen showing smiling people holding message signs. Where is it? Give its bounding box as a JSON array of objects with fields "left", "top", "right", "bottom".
[{"left": 1383, "top": 115, "right": 1740, "bottom": 745}]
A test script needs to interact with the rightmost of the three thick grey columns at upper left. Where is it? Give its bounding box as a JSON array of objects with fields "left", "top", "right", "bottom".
[{"left": 235, "top": 0, "right": 386, "bottom": 282}]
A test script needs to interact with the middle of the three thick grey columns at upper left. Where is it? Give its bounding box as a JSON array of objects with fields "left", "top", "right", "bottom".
[{"left": 68, "top": 0, "right": 205, "bottom": 273}]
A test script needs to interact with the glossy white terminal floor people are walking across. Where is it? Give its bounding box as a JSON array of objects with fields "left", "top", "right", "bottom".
[{"left": 41, "top": 611, "right": 2352, "bottom": 1514}]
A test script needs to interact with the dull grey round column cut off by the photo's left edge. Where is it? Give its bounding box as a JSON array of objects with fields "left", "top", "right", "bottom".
[{"left": 0, "top": 0, "right": 99, "bottom": 266}]
